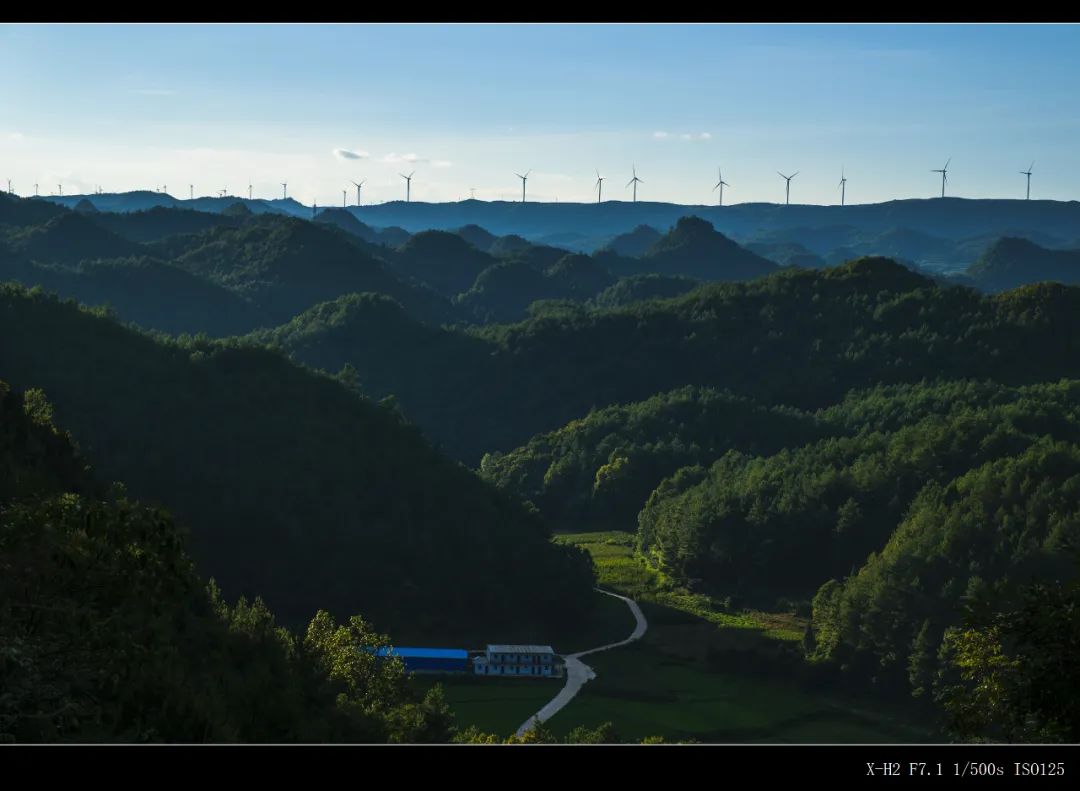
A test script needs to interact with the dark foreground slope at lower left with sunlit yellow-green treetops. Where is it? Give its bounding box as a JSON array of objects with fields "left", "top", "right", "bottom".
[{"left": 0, "top": 381, "right": 451, "bottom": 743}]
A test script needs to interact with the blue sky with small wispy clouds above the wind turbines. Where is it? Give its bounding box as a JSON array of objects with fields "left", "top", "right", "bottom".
[{"left": 0, "top": 24, "right": 1080, "bottom": 205}]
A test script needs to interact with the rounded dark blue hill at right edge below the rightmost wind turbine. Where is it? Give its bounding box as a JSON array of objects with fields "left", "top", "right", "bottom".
[{"left": 964, "top": 238, "right": 1080, "bottom": 292}]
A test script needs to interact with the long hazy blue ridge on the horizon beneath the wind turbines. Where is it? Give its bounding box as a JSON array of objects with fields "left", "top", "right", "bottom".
[{"left": 40, "top": 191, "right": 1080, "bottom": 250}]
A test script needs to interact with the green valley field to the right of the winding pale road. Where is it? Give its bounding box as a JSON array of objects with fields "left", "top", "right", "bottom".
[{"left": 548, "top": 532, "right": 933, "bottom": 743}]
